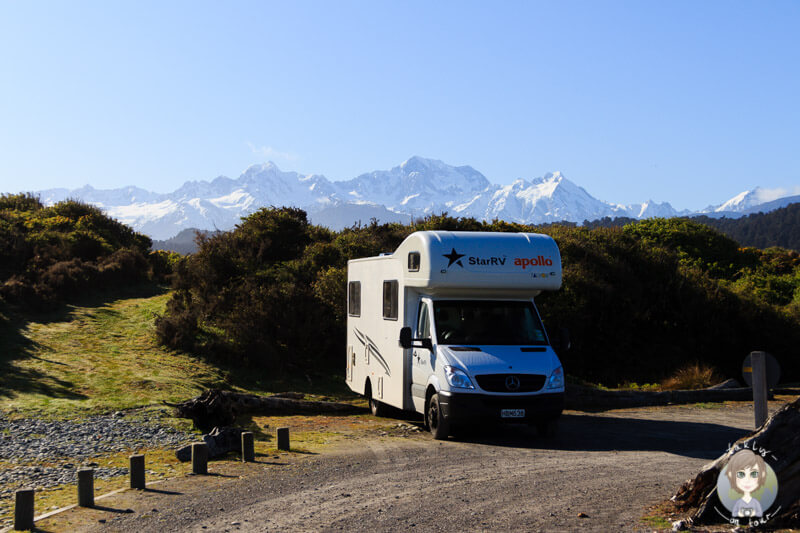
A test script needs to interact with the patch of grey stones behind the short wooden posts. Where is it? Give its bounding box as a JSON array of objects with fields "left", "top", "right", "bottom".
[{"left": 0, "top": 411, "right": 196, "bottom": 527}]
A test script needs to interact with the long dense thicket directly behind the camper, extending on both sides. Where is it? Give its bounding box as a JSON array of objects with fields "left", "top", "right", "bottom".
[{"left": 158, "top": 208, "right": 800, "bottom": 384}]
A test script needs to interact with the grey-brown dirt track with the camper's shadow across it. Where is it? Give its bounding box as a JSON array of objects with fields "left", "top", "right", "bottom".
[{"left": 37, "top": 403, "right": 778, "bottom": 532}]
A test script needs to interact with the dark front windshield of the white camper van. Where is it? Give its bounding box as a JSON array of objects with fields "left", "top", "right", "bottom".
[{"left": 433, "top": 300, "right": 547, "bottom": 345}]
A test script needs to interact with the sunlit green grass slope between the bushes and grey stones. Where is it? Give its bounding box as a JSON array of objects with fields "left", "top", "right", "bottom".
[{"left": 0, "top": 288, "right": 356, "bottom": 416}]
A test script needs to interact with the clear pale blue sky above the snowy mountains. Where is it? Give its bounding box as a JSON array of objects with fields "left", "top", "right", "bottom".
[{"left": 0, "top": 0, "right": 800, "bottom": 209}]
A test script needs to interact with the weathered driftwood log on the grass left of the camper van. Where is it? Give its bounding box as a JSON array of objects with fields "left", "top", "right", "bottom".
[{"left": 168, "top": 389, "right": 365, "bottom": 432}]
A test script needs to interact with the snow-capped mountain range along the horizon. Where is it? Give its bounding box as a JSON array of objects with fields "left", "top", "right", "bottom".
[{"left": 37, "top": 156, "right": 800, "bottom": 239}]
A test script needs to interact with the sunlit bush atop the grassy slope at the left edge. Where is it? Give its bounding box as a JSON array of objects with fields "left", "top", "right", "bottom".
[{"left": 0, "top": 194, "right": 166, "bottom": 310}]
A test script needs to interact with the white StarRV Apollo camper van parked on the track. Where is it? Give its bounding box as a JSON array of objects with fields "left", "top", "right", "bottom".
[{"left": 346, "top": 231, "right": 564, "bottom": 439}]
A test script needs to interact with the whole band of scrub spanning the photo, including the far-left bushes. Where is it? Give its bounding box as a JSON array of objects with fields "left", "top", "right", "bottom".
[{"left": 0, "top": 195, "right": 800, "bottom": 385}]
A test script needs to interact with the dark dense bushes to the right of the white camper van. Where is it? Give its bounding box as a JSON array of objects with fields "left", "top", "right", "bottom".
[{"left": 539, "top": 220, "right": 800, "bottom": 383}]
